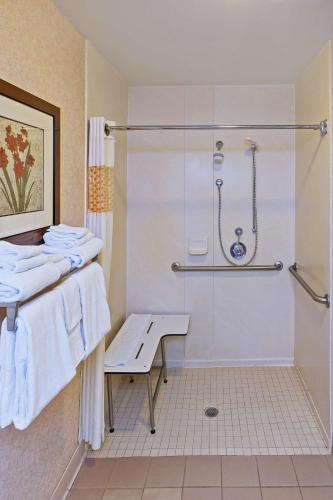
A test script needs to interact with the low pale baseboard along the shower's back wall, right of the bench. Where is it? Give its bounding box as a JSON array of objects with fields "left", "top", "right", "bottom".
[{"left": 183, "top": 358, "right": 294, "bottom": 368}]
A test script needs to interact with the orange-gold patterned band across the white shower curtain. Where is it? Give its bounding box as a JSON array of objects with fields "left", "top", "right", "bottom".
[{"left": 88, "top": 166, "right": 114, "bottom": 213}]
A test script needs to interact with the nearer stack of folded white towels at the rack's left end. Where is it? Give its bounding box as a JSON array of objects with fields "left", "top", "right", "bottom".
[{"left": 0, "top": 241, "right": 69, "bottom": 303}]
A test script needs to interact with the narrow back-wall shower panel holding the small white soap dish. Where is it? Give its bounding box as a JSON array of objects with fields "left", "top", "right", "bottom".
[{"left": 185, "top": 86, "right": 214, "bottom": 365}]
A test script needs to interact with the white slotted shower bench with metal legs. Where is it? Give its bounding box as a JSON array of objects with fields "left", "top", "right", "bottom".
[{"left": 104, "top": 314, "right": 190, "bottom": 434}]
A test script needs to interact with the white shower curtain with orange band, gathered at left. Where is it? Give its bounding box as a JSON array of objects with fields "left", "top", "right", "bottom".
[{"left": 79, "top": 117, "right": 115, "bottom": 450}]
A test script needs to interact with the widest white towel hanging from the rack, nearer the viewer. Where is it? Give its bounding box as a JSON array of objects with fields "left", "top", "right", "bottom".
[{"left": 13, "top": 289, "right": 75, "bottom": 429}]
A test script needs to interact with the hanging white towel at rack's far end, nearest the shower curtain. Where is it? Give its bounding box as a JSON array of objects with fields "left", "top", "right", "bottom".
[{"left": 72, "top": 262, "right": 111, "bottom": 356}]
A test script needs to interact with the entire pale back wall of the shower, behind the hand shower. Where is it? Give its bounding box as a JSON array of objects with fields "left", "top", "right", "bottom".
[{"left": 127, "top": 85, "right": 295, "bottom": 366}]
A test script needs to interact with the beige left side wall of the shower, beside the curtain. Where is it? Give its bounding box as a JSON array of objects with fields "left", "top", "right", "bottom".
[{"left": 87, "top": 42, "right": 128, "bottom": 340}]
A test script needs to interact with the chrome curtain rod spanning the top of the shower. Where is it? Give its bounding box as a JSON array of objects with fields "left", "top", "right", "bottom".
[{"left": 105, "top": 120, "right": 328, "bottom": 137}]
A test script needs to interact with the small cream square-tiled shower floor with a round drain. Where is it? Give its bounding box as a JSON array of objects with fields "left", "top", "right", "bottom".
[{"left": 89, "top": 367, "right": 326, "bottom": 458}]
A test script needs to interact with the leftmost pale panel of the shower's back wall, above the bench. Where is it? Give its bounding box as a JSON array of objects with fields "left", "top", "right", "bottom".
[{"left": 127, "top": 87, "right": 185, "bottom": 361}]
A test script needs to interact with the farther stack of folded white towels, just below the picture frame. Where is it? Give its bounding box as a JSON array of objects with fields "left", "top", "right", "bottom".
[{"left": 42, "top": 224, "right": 103, "bottom": 268}]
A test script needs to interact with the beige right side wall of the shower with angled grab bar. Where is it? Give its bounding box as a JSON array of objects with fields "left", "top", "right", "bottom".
[{"left": 294, "top": 43, "right": 332, "bottom": 442}]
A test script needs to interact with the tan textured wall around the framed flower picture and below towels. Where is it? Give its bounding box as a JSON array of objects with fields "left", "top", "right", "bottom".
[{"left": 0, "top": 0, "right": 85, "bottom": 500}]
